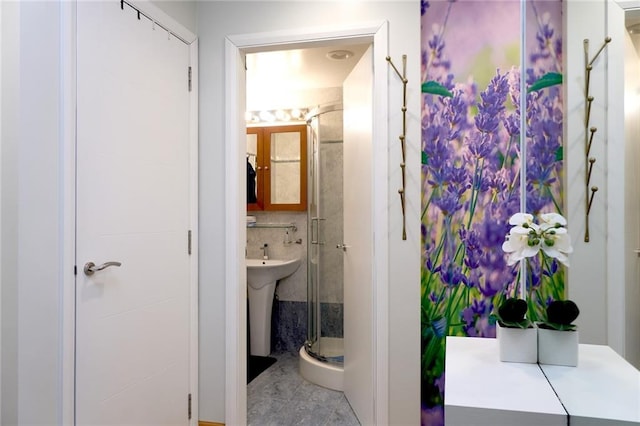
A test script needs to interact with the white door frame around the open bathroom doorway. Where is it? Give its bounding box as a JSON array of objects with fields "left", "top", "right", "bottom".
[{"left": 225, "top": 21, "right": 389, "bottom": 425}]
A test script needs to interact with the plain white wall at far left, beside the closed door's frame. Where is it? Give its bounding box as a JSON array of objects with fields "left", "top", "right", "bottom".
[{"left": 0, "top": 2, "right": 62, "bottom": 425}]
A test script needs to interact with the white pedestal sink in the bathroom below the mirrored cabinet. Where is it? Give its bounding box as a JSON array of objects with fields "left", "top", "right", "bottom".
[{"left": 246, "top": 259, "right": 300, "bottom": 356}]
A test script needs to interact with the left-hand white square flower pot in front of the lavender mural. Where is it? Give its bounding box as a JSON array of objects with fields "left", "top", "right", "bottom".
[{"left": 496, "top": 323, "right": 538, "bottom": 364}]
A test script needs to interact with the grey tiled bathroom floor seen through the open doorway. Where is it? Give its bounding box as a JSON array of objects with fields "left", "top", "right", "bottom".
[{"left": 247, "top": 353, "right": 360, "bottom": 426}]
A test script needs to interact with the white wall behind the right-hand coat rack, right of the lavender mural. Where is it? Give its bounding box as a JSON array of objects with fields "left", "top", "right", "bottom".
[{"left": 564, "top": 1, "right": 607, "bottom": 344}]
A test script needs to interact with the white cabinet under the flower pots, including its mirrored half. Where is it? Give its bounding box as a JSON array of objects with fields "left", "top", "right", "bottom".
[{"left": 445, "top": 337, "right": 640, "bottom": 426}]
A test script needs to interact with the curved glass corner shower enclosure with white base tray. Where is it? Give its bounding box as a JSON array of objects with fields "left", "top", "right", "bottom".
[{"left": 300, "top": 104, "right": 344, "bottom": 390}]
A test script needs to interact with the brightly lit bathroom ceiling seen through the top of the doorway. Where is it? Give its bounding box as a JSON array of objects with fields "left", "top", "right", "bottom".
[{"left": 246, "top": 44, "right": 368, "bottom": 110}]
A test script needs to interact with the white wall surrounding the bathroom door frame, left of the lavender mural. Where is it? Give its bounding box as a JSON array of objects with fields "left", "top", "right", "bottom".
[{"left": 198, "top": 0, "right": 421, "bottom": 425}]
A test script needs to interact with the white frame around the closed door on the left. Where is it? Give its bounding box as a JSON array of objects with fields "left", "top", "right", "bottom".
[{"left": 60, "top": 0, "right": 198, "bottom": 425}]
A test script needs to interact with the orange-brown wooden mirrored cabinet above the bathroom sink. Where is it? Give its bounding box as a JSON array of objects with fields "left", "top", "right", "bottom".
[{"left": 247, "top": 125, "right": 307, "bottom": 211}]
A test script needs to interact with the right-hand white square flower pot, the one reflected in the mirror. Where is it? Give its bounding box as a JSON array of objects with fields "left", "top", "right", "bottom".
[{"left": 538, "top": 328, "right": 579, "bottom": 367}]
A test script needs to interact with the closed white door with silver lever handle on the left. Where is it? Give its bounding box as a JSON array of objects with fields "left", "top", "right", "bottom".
[{"left": 75, "top": 2, "right": 190, "bottom": 426}]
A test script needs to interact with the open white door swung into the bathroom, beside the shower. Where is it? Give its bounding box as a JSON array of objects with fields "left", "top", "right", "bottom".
[{"left": 343, "top": 47, "right": 375, "bottom": 425}]
